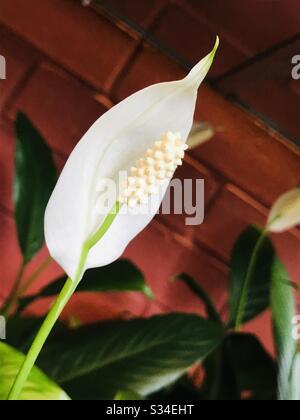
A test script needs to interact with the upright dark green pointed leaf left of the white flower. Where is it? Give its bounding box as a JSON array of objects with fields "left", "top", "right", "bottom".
[{"left": 14, "top": 113, "right": 56, "bottom": 263}]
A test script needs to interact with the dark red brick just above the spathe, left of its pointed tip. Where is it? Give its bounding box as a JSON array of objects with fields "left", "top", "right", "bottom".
[{"left": 114, "top": 45, "right": 185, "bottom": 100}]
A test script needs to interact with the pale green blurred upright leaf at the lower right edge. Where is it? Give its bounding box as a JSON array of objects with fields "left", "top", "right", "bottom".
[{"left": 271, "top": 260, "right": 300, "bottom": 401}]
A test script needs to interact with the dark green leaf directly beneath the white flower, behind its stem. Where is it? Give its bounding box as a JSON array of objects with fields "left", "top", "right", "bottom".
[{"left": 19, "top": 260, "right": 153, "bottom": 310}]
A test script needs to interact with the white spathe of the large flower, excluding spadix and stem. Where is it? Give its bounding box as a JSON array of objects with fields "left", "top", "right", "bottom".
[{"left": 45, "top": 39, "right": 219, "bottom": 278}]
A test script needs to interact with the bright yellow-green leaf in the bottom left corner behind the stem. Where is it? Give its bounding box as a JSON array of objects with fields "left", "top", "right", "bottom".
[{"left": 0, "top": 341, "right": 69, "bottom": 400}]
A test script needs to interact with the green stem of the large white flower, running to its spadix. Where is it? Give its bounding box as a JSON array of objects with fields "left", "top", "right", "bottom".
[{"left": 8, "top": 202, "right": 121, "bottom": 400}]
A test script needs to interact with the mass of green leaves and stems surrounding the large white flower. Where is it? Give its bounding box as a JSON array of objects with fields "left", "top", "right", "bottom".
[{"left": 0, "top": 44, "right": 300, "bottom": 400}]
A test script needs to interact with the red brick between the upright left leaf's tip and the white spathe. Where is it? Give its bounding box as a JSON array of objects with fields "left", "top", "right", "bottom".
[{"left": 9, "top": 64, "right": 107, "bottom": 155}]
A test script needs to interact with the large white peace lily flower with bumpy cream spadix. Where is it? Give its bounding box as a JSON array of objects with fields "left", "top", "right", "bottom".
[{"left": 45, "top": 39, "right": 219, "bottom": 279}]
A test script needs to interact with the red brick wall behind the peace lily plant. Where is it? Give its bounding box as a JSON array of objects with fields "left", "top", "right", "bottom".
[{"left": 0, "top": 0, "right": 300, "bottom": 351}]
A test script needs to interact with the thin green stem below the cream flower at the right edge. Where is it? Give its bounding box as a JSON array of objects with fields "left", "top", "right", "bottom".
[{"left": 235, "top": 230, "right": 267, "bottom": 332}]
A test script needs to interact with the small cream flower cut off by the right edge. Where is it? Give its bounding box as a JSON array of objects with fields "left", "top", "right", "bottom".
[{"left": 267, "top": 188, "right": 300, "bottom": 233}]
